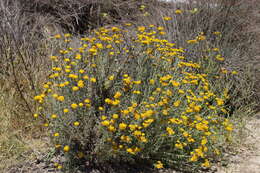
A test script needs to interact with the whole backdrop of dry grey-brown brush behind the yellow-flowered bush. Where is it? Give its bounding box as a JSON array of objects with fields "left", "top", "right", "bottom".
[{"left": 0, "top": 0, "right": 260, "bottom": 172}]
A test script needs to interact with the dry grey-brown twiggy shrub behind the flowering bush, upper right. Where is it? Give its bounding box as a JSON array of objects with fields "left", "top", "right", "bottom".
[{"left": 142, "top": 0, "right": 260, "bottom": 109}]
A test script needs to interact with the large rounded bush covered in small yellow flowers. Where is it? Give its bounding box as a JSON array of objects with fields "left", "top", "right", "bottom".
[{"left": 34, "top": 17, "right": 236, "bottom": 169}]
